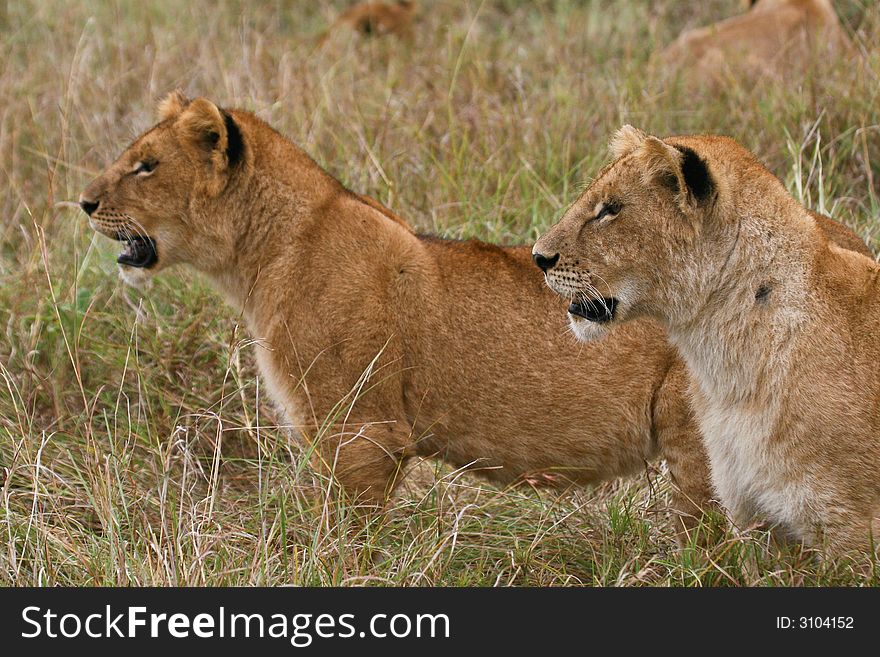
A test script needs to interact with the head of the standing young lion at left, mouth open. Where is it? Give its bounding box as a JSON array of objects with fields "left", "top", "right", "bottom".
[{"left": 80, "top": 92, "right": 244, "bottom": 280}]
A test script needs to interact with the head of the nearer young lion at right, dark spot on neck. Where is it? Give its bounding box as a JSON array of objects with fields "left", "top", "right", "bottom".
[{"left": 533, "top": 126, "right": 720, "bottom": 340}]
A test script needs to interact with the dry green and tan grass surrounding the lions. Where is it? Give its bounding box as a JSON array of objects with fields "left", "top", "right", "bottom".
[{"left": 0, "top": 0, "right": 880, "bottom": 586}]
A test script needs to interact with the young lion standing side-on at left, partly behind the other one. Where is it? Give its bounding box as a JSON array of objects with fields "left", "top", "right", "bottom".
[{"left": 83, "top": 98, "right": 711, "bottom": 540}]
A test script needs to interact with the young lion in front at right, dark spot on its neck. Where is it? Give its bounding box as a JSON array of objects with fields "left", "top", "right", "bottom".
[{"left": 534, "top": 126, "right": 880, "bottom": 552}]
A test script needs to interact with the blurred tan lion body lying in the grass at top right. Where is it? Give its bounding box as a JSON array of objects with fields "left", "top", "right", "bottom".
[{"left": 656, "top": 0, "right": 854, "bottom": 86}]
